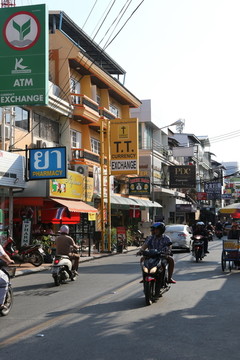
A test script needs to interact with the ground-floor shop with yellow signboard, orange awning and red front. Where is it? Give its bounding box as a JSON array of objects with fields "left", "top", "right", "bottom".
[{"left": 14, "top": 170, "right": 98, "bottom": 243}]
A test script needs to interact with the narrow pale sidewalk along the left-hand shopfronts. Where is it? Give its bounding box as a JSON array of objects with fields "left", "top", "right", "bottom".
[{"left": 15, "top": 246, "right": 137, "bottom": 277}]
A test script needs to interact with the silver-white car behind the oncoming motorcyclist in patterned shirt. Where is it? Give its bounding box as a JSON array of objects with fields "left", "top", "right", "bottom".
[{"left": 165, "top": 224, "right": 192, "bottom": 252}]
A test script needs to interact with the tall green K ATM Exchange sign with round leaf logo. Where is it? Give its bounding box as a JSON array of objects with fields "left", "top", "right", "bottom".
[{"left": 0, "top": 5, "right": 48, "bottom": 106}]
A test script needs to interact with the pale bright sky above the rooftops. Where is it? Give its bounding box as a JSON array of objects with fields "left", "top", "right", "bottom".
[{"left": 16, "top": 0, "right": 240, "bottom": 170}]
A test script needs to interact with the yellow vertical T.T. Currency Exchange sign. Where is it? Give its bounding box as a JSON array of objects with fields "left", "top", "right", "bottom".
[{"left": 110, "top": 118, "right": 139, "bottom": 175}]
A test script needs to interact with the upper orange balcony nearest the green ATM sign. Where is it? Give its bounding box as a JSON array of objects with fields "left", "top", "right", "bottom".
[{"left": 70, "top": 93, "right": 99, "bottom": 124}]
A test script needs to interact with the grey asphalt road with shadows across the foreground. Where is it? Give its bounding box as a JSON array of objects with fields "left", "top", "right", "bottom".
[{"left": 0, "top": 239, "right": 239, "bottom": 360}]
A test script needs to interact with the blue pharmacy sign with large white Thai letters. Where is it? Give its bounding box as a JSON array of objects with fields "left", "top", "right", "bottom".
[{"left": 28, "top": 147, "right": 67, "bottom": 180}]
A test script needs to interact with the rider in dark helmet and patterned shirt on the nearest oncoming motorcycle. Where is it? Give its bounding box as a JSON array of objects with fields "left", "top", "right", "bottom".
[{"left": 138, "top": 222, "right": 176, "bottom": 284}]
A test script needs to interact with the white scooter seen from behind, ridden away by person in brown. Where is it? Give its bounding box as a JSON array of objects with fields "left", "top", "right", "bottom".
[{"left": 52, "top": 255, "right": 77, "bottom": 286}]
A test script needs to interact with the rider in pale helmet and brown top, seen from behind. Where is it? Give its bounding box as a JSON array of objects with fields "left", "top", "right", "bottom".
[{"left": 55, "top": 225, "right": 79, "bottom": 275}]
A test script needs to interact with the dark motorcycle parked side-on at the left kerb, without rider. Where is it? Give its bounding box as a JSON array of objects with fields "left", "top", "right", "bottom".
[{"left": 3, "top": 237, "right": 44, "bottom": 266}]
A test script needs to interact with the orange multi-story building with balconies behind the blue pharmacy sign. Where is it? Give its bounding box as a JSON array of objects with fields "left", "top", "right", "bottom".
[{"left": 1, "top": 11, "right": 140, "bottom": 250}]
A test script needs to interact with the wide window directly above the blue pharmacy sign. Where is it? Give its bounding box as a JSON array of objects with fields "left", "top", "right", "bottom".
[{"left": 33, "top": 113, "right": 59, "bottom": 143}]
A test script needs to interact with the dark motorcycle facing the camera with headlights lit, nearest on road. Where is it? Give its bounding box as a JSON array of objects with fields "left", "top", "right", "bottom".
[{"left": 137, "top": 249, "right": 170, "bottom": 305}]
